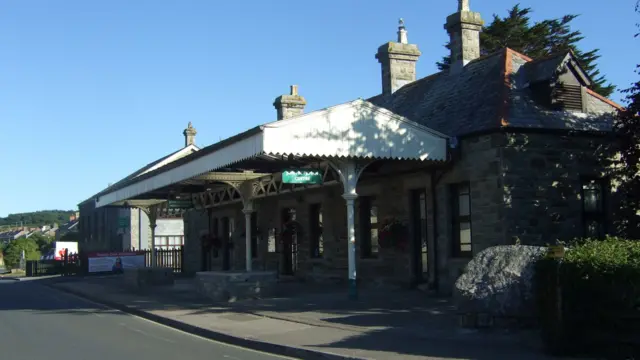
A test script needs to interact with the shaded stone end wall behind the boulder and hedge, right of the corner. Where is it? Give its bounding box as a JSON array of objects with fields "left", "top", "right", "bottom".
[{"left": 502, "top": 133, "right": 613, "bottom": 245}]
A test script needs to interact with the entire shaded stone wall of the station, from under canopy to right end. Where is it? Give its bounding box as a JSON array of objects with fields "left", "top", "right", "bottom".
[{"left": 180, "top": 133, "right": 616, "bottom": 293}]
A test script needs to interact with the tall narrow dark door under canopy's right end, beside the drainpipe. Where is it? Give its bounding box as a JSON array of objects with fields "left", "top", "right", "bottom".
[{"left": 410, "top": 189, "right": 429, "bottom": 284}]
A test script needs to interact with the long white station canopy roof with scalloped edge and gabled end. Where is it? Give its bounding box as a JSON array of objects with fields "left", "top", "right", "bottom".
[{"left": 95, "top": 99, "right": 447, "bottom": 207}]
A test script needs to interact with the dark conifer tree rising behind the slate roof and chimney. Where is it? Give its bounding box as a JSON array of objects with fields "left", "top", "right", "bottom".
[{"left": 437, "top": 4, "right": 615, "bottom": 97}]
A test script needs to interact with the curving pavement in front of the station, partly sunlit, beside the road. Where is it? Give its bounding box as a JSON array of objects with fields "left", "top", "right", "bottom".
[{"left": 32, "top": 277, "right": 576, "bottom": 360}]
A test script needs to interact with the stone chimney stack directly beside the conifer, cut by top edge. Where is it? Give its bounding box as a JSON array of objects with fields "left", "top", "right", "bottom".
[{"left": 444, "top": 0, "right": 484, "bottom": 72}]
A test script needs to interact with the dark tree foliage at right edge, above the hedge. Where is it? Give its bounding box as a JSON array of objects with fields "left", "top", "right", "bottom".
[{"left": 610, "top": 1, "right": 640, "bottom": 239}]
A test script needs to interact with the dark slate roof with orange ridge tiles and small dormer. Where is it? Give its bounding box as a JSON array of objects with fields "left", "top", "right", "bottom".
[{"left": 369, "top": 49, "right": 616, "bottom": 136}]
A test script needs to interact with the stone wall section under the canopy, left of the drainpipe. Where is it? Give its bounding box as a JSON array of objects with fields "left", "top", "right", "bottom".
[{"left": 185, "top": 171, "right": 435, "bottom": 286}]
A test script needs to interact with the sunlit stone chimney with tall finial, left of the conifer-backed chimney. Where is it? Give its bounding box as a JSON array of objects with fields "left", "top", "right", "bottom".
[{"left": 376, "top": 19, "right": 422, "bottom": 95}]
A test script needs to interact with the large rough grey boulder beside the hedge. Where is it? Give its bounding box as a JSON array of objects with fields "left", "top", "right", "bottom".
[{"left": 453, "top": 245, "right": 547, "bottom": 318}]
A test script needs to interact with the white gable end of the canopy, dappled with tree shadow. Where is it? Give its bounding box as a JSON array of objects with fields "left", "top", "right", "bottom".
[{"left": 262, "top": 99, "right": 447, "bottom": 159}]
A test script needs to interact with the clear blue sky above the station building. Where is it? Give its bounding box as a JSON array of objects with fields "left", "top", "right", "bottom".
[{"left": 0, "top": 0, "right": 640, "bottom": 216}]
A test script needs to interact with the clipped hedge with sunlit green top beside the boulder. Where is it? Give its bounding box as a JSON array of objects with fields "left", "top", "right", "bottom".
[{"left": 536, "top": 237, "right": 640, "bottom": 354}]
